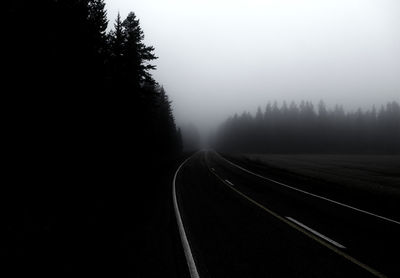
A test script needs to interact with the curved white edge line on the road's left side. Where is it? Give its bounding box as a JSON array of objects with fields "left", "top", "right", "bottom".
[{"left": 172, "top": 155, "right": 200, "bottom": 278}]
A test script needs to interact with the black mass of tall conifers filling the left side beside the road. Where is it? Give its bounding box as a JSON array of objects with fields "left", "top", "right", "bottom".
[{"left": 4, "top": 0, "right": 180, "bottom": 277}]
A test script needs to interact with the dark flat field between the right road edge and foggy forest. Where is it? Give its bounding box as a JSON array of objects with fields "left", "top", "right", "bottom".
[{"left": 236, "top": 154, "right": 400, "bottom": 197}]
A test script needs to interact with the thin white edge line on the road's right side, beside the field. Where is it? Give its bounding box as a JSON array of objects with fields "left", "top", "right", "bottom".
[{"left": 215, "top": 152, "right": 400, "bottom": 225}]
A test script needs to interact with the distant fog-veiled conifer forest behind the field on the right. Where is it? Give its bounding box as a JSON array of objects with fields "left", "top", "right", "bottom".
[{"left": 213, "top": 101, "right": 400, "bottom": 154}]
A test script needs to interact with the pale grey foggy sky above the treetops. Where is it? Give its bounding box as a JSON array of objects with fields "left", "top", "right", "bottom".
[{"left": 105, "top": 0, "right": 400, "bottom": 134}]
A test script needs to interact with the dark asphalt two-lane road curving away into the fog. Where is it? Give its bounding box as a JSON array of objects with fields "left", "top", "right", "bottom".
[{"left": 173, "top": 151, "right": 400, "bottom": 277}]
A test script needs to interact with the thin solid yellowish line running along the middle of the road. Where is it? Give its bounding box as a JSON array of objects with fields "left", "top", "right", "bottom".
[{"left": 206, "top": 161, "right": 387, "bottom": 278}]
